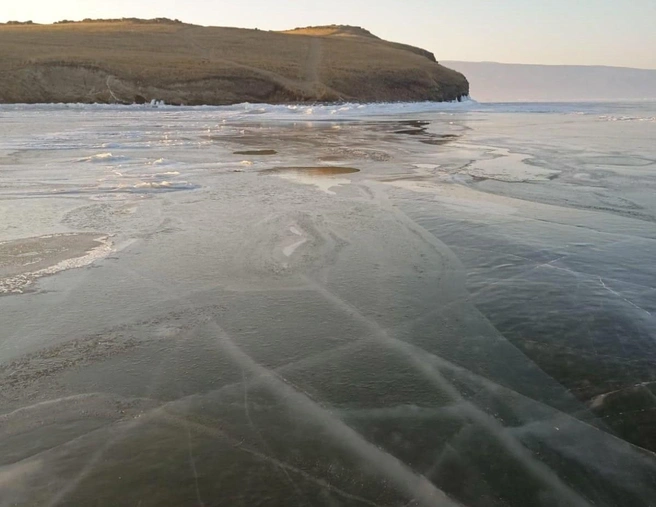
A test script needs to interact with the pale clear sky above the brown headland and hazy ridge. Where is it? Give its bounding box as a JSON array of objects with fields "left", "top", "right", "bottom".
[{"left": 0, "top": 0, "right": 656, "bottom": 69}]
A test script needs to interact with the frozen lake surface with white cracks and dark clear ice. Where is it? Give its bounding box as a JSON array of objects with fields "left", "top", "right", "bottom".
[{"left": 0, "top": 102, "right": 656, "bottom": 507}]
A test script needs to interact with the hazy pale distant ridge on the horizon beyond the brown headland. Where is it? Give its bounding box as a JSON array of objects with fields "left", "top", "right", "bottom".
[{"left": 442, "top": 61, "right": 656, "bottom": 102}]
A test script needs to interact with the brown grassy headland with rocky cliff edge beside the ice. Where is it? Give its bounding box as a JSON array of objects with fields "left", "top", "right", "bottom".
[{"left": 0, "top": 20, "right": 469, "bottom": 105}]
